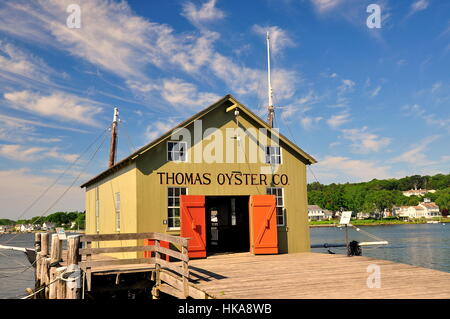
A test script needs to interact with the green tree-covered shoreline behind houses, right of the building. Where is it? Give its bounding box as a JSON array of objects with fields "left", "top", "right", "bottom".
[{"left": 308, "top": 174, "right": 450, "bottom": 215}]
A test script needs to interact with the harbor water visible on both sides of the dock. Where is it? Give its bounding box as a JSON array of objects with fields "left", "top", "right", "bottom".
[{"left": 0, "top": 223, "right": 450, "bottom": 299}]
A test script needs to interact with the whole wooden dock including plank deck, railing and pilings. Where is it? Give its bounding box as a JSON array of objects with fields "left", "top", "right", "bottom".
[{"left": 29, "top": 233, "right": 450, "bottom": 299}]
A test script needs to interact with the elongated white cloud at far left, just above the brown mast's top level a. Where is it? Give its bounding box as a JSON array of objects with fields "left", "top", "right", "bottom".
[{"left": 3, "top": 91, "right": 102, "bottom": 126}]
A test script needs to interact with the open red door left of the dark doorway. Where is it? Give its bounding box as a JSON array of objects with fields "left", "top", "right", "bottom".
[{"left": 180, "top": 195, "right": 206, "bottom": 258}]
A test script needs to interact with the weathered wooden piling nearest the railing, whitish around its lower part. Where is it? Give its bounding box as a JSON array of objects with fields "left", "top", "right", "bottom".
[{"left": 66, "top": 235, "right": 81, "bottom": 299}]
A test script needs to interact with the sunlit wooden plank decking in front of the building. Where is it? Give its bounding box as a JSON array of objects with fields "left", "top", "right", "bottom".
[{"left": 189, "top": 253, "right": 450, "bottom": 299}]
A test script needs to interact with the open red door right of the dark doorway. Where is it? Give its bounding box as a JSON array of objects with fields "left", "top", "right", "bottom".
[{"left": 249, "top": 195, "right": 278, "bottom": 255}]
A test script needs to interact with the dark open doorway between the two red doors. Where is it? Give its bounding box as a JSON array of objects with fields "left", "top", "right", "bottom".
[{"left": 205, "top": 196, "right": 250, "bottom": 255}]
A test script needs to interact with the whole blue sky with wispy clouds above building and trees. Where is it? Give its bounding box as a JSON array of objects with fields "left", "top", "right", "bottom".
[{"left": 0, "top": 0, "right": 450, "bottom": 218}]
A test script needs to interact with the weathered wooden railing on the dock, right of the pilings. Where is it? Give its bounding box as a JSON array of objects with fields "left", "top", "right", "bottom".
[{"left": 79, "top": 232, "right": 189, "bottom": 298}]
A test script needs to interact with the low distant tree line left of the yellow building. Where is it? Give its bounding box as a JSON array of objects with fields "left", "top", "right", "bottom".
[{"left": 0, "top": 212, "right": 86, "bottom": 229}]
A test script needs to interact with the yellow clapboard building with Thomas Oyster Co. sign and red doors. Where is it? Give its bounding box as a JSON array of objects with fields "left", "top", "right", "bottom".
[{"left": 81, "top": 95, "right": 316, "bottom": 258}]
